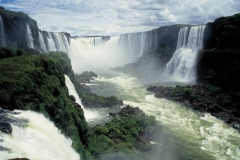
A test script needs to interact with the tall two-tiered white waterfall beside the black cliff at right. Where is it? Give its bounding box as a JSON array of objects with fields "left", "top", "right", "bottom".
[{"left": 166, "top": 26, "right": 205, "bottom": 83}]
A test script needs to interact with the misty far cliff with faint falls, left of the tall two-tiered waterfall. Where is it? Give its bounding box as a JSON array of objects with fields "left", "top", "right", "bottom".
[{"left": 119, "top": 25, "right": 189, "bottom": 60}]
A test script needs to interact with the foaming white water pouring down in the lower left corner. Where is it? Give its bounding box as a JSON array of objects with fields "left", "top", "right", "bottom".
[{"left": 0, "top": 111, "right": 80, "bottom": 160}]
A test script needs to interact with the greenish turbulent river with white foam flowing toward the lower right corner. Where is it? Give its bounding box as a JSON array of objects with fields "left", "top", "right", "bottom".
[{"left": 87, "top": 75, "right": 240, "bottom": 160}]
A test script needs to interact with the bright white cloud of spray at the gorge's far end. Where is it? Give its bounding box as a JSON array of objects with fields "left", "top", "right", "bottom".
[{"left": 70, "top": 37, "right": 133, "bottom": 73}]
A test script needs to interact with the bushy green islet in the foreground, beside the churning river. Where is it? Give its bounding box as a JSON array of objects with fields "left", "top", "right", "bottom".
[{"left": 88, "top": 106, "right": 160, "bottom": 160}]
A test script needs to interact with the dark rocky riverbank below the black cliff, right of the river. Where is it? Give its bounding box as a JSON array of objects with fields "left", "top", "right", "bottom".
[{"left": 147, "top": 85, "right": 240, "bottom": 131}]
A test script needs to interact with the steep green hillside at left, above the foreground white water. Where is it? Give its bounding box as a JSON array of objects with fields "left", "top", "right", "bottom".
[{"left": 0, "top": 48, "right": 88, "bottom": 157}]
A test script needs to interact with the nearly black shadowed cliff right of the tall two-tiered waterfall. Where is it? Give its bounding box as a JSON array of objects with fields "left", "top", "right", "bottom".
[{"left": 197, "top": 14, "right": 240, "bottom": 90}]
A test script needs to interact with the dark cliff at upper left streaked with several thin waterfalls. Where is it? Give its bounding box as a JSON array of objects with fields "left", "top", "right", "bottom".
[{"left": 0, "top": 7, "right": 70, "bottom": 53}]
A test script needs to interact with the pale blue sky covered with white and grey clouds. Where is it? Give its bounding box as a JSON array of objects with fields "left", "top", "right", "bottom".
[{"left": 0, "top": 0, "right": 240, "bottom": 36}]
